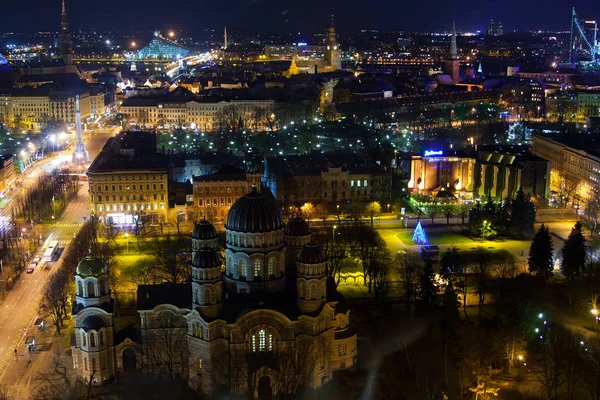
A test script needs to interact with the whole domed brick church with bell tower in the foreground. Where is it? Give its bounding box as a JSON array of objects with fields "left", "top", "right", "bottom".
[{"left": 72, "top": 190, "right": 357, "bottom": 398}]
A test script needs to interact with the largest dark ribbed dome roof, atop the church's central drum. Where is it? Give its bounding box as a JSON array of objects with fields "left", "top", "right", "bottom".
[{"left": 225, "top": 189, "right": 284, "bottom": 233}]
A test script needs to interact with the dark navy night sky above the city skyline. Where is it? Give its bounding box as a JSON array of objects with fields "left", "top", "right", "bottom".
[{"left": 0, "top": 0, "right": 600, "bottom": 34}]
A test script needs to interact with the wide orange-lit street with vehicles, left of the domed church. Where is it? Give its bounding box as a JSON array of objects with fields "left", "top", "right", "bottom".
[{"left": 0, "top": 132, "right": 112, "bottom": 392}]
